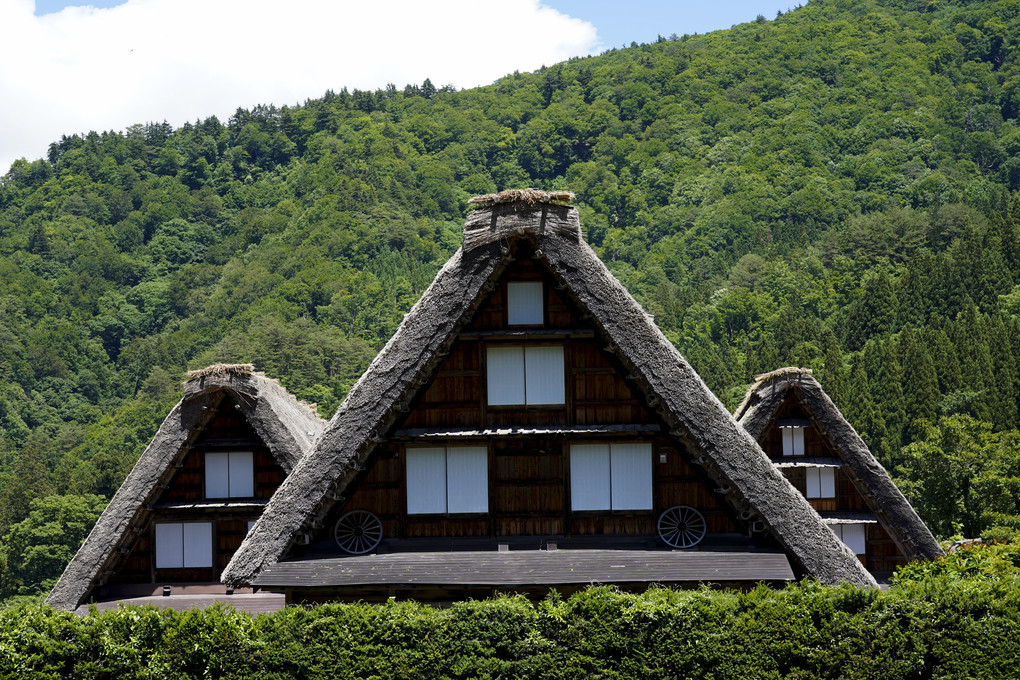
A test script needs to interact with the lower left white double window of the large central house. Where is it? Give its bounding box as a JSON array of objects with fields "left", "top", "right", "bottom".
[{"left": 407, "top": 447, "right": 489, "bottom": 515}]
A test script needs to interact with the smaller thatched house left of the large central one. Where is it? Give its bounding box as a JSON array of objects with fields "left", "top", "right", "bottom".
[{"left": 47, "top": 364, "right": 325, "bottom": 610}]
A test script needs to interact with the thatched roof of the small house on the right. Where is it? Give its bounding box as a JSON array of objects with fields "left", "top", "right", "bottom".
[{"left": 734, "top": 368, "right": 942, "bottom": 560}]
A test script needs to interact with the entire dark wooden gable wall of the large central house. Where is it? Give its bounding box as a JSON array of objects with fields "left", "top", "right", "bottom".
[{"left": 294, "top": 259, "right": 747, "bottom": 558}]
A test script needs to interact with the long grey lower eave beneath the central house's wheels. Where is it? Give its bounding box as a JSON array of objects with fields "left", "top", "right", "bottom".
[{"left": 253, "top": 550, "right": 794, "bottom": 588}]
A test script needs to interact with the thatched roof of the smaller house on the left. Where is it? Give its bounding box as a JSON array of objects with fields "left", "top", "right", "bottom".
[{"left": 46, "top": 364, "right": 325, "bottom": 610}]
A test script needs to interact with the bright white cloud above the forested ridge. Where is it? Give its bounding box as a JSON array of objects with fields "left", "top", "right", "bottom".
[{"left": 0, "top": 0, "right": 598, "bottom": 174}]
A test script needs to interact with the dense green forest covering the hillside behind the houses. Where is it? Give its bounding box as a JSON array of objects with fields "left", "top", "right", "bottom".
[{"left": 0, "top": 0, "right": 1020, "bottom": 595}]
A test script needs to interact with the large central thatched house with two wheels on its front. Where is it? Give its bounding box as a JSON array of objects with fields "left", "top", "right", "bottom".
[{"left": 222, "top": 190, "right": 874, "bottom": 598}]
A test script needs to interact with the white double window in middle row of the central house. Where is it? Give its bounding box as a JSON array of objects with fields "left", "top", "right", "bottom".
[{"left": 486, "top": 346, "right": 566, "bottom": 406}]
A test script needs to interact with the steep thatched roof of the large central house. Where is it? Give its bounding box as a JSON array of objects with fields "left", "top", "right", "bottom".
[{"left": 222, "top": 196, "right": 874, "bottom": 585}]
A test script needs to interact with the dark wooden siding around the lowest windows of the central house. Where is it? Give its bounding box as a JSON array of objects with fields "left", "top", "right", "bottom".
[{"left": 317, "top": 435, "right": 744, "bottom": 550}]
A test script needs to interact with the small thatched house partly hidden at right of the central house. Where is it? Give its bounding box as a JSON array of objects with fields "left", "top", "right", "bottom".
[{"left": 734, "top": 368, "right": 942, "bottom": 575}]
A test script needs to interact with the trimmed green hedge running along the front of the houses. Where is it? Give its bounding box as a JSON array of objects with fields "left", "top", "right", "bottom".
[{"left": 0, "top": 575, "right": 1020, "bottom": 680}]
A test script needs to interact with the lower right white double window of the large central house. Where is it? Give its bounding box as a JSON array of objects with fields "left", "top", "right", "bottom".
[{"left": 570, "top": 442, "right": 652, "bottom": 510}]
